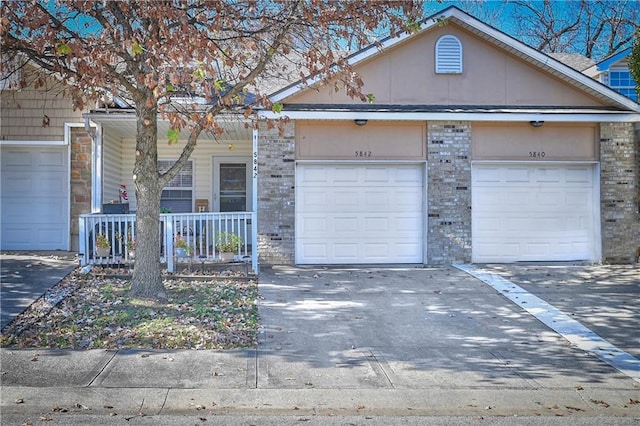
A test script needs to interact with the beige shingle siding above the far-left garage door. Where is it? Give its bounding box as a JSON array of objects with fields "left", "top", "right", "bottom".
[{"left": 0, "top": 68, "right": 82, "bottom": 141}]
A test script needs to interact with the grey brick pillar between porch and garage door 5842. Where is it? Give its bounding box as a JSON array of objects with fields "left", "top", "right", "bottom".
[{"left": 258, "top": 123, "right": 295, "bottom": 264}]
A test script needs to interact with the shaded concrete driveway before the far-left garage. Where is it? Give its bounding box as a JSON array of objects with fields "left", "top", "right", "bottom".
[{"left": 0, "top": 251, "right": 78, "bottom": 329}]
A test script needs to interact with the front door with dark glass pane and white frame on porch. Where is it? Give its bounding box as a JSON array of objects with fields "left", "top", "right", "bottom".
[{"left": 213, "top": 157, "right": 253, "bottom": 212}]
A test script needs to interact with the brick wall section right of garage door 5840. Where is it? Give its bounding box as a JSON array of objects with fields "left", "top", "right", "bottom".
[{"left": 600, "top": 123, "right": 640, "bottom": 263}]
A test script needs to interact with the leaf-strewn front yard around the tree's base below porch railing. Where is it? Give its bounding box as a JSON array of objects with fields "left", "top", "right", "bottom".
[{"left": 0, "top": 268, "right": 258, "bottom": 349}]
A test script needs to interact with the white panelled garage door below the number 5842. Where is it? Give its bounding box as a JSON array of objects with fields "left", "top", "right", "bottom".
[{"left": 296, "top": 164, "right": 425, "bottom": 264}]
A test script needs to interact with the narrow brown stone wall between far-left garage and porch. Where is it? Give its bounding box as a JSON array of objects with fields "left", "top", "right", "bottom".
[{"left": 71, "top": 127, "right": 92, "bottom": 251}]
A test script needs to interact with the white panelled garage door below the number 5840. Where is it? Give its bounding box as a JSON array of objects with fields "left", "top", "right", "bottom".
[{"left": 472, "top": 165, "right": 596, "bottom": 263}]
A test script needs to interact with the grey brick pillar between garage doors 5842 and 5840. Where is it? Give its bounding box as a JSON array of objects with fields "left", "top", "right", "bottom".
[{"left": 425, "top": 121, "right": 471, "bottom": 264}]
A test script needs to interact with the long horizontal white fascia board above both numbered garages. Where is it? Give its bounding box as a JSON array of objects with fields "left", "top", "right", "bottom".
[{"left": 258, "top": 111, "right": 640, "bottom": 123}]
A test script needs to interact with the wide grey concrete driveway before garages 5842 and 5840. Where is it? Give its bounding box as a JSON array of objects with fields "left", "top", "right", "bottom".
[{"left": 258, "top": 266, "right": 640, "bottom": 390}]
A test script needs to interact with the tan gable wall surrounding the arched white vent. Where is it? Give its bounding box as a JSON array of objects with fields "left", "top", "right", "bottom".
[{"left": 286, "top": 23, "right": 601, "bottom": 106}]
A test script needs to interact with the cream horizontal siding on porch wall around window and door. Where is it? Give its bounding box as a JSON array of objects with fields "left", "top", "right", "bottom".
[{"left": 119, "top": 139, "right": 253, "bottom": 210}]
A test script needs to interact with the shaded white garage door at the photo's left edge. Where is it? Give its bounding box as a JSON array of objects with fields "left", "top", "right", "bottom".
[{"left": 0, "top": 146, "right": 69, "bottom": 250}]
